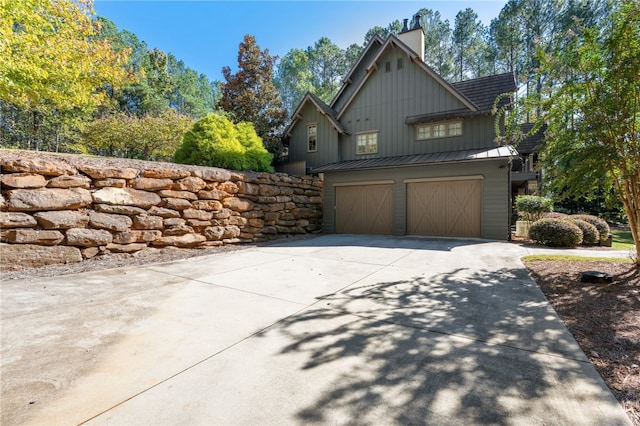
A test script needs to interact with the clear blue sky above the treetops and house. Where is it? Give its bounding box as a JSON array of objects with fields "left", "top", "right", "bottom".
[{"left": 94, "top": 0, "right": 506, "bottom": 80}]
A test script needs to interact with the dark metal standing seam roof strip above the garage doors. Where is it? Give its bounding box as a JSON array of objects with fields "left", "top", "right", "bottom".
[{"left": 311, "top": 145, "right": 518, "bottom": 173}]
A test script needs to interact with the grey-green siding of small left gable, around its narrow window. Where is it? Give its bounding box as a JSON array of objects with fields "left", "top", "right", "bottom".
[{"left": 289, "top": 102, "right": 339, "bottom": 168}]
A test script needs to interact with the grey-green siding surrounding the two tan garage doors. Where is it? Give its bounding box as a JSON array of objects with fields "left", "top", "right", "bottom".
[{"left": 323, "top": 159, "right": 509, "bottom": 240}]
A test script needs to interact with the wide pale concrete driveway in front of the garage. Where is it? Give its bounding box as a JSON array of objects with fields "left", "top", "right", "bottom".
[{"left": 1, "top": 235, "right": 630, "bottom": 425}]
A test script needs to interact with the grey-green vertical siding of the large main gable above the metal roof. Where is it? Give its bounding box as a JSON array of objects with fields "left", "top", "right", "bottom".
[{"left": 340, "top": 48, "right": 495, "bottom": 161}]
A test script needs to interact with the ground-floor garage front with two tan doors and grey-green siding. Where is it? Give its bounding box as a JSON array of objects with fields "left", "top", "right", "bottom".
[{"left": 323, "top": 151, "right": 510, "bottom": 240}]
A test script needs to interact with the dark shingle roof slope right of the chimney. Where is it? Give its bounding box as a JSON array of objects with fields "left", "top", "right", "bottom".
[{"left": 451, "top": 73, "right": 517, "bottom": 112}]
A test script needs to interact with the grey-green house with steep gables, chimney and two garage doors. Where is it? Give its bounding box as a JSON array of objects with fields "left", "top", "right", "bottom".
[{"left": 283, "top": 17, "right": 517, "bottom": 240}]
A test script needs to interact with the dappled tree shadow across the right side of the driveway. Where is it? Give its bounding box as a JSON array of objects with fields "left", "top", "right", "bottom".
[{"left": 267, "top": 269, "right": 626, "bottom": 425}]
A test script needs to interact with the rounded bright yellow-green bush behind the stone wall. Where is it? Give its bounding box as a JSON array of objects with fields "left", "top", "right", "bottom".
[{"left": 174, "top": 114, "right": 273, "bottom": 172}]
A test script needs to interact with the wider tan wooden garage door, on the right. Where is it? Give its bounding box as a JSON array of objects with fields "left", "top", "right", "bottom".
[{"left": 407, "top": 179, "right": 481, "bottom": 237}]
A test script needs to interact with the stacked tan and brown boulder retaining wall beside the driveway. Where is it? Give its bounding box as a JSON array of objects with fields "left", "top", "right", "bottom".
[{"left": 0, "top": 150, "right": 322, "bottom": 270}]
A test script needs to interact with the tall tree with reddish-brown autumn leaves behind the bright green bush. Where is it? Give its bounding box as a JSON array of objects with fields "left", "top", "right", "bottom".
[{"left": 218, "top": 34, "right": 287, "bottom": 156}]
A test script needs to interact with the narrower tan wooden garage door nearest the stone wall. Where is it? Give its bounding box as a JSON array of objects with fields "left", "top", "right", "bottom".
[{"left": 336, "top": 184, "right": 393, "bottom": 235}]
